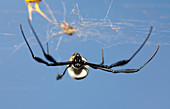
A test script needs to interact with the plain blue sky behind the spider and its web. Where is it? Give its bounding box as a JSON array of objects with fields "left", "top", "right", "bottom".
[{"left": 0, "top": 0, "right": 170, "bottom": 109}]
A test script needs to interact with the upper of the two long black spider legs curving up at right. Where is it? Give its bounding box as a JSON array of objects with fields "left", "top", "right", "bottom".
[{"left": 108, "top": 26, "right": 153, "bottom": 68}]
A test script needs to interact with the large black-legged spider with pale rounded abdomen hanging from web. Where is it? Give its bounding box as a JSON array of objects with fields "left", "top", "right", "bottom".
[{"left": 20, "top": 20, "right": 159, "bottom": 80}]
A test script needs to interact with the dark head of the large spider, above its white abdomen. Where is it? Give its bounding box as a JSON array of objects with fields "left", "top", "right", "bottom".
[{"left": 72, "top": 53, "right": 83, "bottom": 68}]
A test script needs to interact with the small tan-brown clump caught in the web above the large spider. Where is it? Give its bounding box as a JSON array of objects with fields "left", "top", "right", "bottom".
[{"left": 58, "top": 21, "right": 76, "bottom": 35}]
